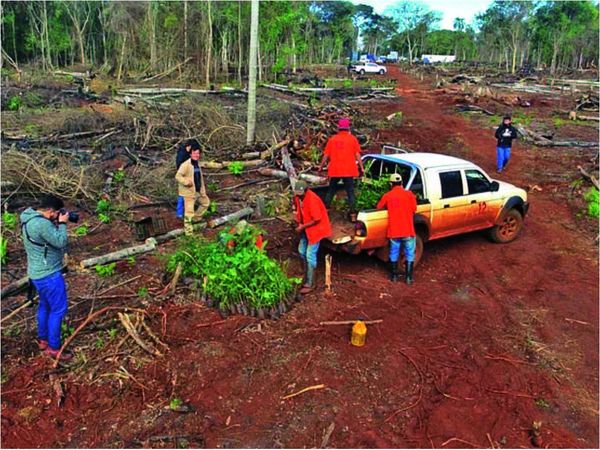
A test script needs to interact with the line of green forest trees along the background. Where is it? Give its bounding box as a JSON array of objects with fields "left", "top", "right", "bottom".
[{"left": 0, "top": 0, "right": 598, "bottom": 85}]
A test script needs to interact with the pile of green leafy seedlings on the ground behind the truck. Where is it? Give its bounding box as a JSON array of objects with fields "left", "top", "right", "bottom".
[{"left": 166, "top": 222, "right": 301, "bottom": 319}]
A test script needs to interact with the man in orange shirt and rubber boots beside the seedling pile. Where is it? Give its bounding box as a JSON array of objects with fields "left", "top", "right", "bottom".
[{"left": 294, "top": 181, "right": 331, "bottom": 294}]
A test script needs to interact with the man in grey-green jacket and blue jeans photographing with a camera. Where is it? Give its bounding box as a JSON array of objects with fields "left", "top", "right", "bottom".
[{"left": 21, "top": 195, "right": 78, "bottom": 360}]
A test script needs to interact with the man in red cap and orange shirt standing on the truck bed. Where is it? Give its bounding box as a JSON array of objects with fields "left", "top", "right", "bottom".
[{"left": 319, "top": 118, "right": 365, "bottom": 212}]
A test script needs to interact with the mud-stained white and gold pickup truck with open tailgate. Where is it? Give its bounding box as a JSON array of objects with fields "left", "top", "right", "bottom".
[{"left": 318, "top": 153, "right": 529, "bottom": 264}]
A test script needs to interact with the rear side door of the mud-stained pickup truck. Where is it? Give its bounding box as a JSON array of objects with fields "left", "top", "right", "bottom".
[{"left": 430, "top": 169, "right": 468, "bottom": 238}]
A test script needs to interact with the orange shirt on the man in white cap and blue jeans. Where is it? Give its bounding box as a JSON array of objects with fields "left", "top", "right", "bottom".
[{"left": 377, "top": 186, "right": 417, "bottom": 239}]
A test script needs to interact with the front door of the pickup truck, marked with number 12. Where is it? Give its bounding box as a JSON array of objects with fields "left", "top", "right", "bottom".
[{"left": 465, "top": 169, "right": 502, "bottom": 230}]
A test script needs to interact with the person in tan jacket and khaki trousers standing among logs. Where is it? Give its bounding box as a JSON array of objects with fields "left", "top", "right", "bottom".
[{"left": 175, "top": 142, "right": 210, "bottom": 236}]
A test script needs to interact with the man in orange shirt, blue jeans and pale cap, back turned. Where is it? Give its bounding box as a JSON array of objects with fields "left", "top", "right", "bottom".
[{"left": 377, "top": 173, "right": 417, "bottom": 284}]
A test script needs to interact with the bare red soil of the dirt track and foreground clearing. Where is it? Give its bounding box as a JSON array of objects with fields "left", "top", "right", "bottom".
[{"left": 2, "top": 68, "right": 599, "bottom": 448}]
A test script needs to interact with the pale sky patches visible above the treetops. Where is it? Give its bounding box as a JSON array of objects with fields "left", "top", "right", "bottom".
[{"left": 352, "top": 0, "right": 492, "bottom": 30}]
